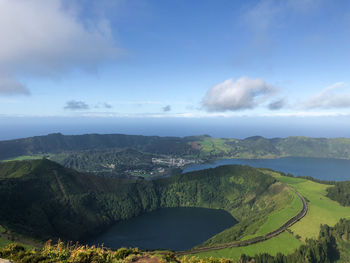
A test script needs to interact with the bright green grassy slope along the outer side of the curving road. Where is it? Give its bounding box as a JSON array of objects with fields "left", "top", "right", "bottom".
[{"left": 196, "top": 171, "right": 350, "bottom": 259}]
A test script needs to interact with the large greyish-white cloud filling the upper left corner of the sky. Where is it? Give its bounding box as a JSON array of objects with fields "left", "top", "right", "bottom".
[{"left": 0, "top": 0, "right": 121, "bottom": 94}]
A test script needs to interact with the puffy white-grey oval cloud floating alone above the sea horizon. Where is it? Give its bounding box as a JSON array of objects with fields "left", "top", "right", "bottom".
[{"left": 202, "top": 77, "right": 276, "bottom": 112}]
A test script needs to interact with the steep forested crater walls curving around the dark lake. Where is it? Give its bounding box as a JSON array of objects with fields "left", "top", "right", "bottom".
[{"left": 0, "top": 159, "right": 290, "bottom": 249}]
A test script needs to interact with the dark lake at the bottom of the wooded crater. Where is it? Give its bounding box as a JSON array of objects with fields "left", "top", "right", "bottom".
[{"left": 90, "top": 208, "right": 237, "bottom": 250}]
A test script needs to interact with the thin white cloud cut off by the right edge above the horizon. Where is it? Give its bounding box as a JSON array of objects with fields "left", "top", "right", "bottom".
[{"left": 303, "top": 82, "right": 350, "bottom": 109}]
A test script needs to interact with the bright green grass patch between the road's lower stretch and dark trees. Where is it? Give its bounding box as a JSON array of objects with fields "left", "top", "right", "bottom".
[{"left": 193, "top": 232, "right": 302, "bottom": 261}]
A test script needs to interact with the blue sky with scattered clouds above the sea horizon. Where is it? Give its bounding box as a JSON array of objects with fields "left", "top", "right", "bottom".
[{"left": 0, "top": 0, "right": 350, "bottom": 139}]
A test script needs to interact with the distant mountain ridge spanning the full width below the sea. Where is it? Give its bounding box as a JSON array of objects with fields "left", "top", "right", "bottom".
[{"left": 0, "top": 133, "right": 350, "bottom": 160}]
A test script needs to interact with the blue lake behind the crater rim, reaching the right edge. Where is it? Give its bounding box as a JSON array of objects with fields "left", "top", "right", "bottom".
[{"left": 183, "top": 157, "right": 350, "bottom": 181}]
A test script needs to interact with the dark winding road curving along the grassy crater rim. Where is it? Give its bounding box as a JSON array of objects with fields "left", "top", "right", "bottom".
[{"left": 175, "top": 188, "right": 308, "bottom": 256}]
